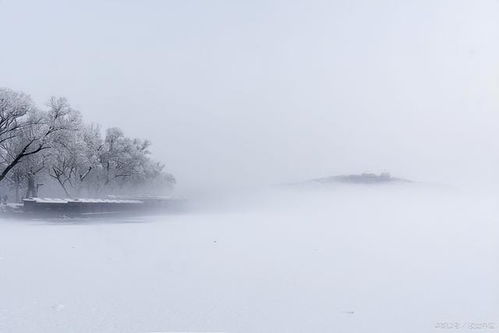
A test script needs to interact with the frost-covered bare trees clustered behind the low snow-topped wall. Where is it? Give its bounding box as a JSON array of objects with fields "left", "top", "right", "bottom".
[{"left": 0, "top": 88, "right": 175, "bottom": 201}]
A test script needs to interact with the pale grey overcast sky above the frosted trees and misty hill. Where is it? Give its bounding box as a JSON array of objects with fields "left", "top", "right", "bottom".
[{"left": 0, "top": 0, "right": 499, "bottom": 188}]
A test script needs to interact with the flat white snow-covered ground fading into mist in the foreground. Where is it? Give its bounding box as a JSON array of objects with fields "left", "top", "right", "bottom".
[{"left": 0, "top": 186, "right": 499, "bottom": 333}]
